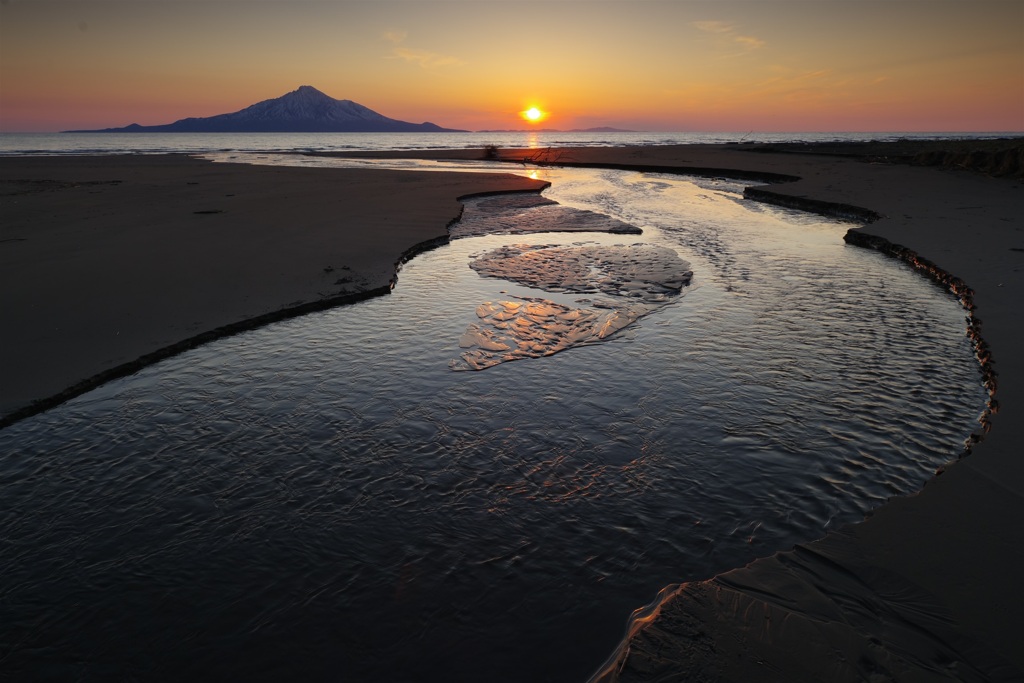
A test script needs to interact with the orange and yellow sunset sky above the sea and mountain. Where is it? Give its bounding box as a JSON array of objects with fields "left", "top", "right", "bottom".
[{"left": 0, "top": 0, "right": 1024, "bottom": 132}]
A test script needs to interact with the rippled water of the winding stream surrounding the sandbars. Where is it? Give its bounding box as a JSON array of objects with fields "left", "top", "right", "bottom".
[{"left": 0, "top": 161, "right": 984, "bottom": 681}]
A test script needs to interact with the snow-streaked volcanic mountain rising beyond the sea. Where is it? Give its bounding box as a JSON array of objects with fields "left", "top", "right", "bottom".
[{"left": 67, "top": 85, "right": 463, "bottom": 133}]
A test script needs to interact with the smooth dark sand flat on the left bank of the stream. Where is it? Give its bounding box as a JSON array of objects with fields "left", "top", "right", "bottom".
[{"left": 0, "top": 155, "right": 545, "bottom": 427}]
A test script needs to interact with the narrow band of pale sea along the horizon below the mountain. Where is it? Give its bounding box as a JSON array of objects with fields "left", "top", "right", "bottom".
[{"left": 0, "top": 132, "right": 1020, "bottom": 155}]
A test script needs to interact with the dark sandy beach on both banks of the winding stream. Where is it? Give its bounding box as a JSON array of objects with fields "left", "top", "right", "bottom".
[{"left": 0, "top": 145, "right": 1024, "bottom": 681}]
